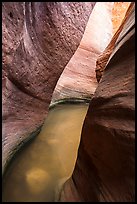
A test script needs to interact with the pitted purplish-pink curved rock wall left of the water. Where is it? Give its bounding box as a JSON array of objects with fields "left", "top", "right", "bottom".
[{"left": 2, "top": 2, "right": 95, "bottom": 172}]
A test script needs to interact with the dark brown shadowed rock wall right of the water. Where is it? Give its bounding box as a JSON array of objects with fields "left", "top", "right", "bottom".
[{"left": 60, "top": 3, "right": 135, "bottom": 202}]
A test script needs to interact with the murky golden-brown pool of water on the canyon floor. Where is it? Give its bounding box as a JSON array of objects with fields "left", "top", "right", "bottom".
[{"left": 3, "top": 103, "right": 88, "bottom": 202}]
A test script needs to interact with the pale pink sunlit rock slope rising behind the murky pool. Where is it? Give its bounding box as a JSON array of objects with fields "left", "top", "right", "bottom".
[{"left": 52, "top": 2, "right": 114, "bottom": 101}]
